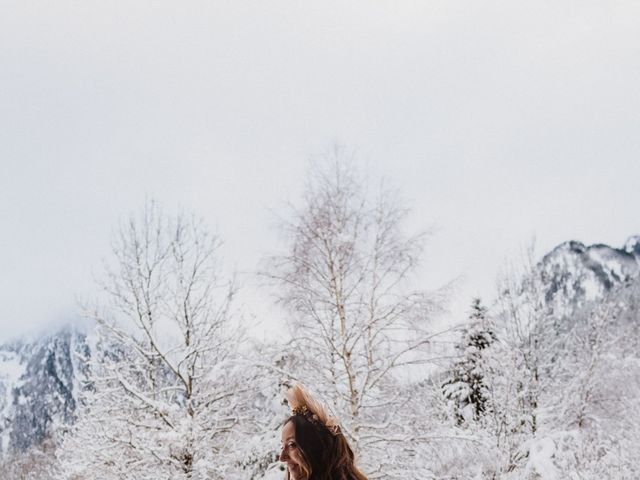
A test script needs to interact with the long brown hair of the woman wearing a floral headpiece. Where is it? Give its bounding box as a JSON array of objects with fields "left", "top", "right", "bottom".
[{"left": 284, "top": 414, "right": 367, "bottom": 480}]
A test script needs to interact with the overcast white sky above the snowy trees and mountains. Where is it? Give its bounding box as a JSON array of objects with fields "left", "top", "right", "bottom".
[{"left": 0, "top": 0, "right": 640, "bottom": 340}]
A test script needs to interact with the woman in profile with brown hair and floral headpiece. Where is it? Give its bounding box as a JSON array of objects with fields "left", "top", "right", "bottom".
[{"left": 280, "top": 385, "right": 367, "bottom": 480}]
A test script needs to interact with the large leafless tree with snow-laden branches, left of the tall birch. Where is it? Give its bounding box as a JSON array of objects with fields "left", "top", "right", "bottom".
[{"left": 59, "top": 203, "right": 249, "bottom": 480}]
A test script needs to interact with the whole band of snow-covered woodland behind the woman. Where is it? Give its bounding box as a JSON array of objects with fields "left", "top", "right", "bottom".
[{"left": 0, "top": 161, "right": 640, "bottom": 480}]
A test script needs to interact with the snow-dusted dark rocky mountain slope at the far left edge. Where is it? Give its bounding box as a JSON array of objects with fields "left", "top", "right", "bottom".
[{"left": 0, "top": 328, "right": 89, "bottom": 454}]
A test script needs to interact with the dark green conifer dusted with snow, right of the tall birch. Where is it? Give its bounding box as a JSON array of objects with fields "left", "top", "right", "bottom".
[{"left": 442, "top": 298, "right": 495, "bottom": 424}]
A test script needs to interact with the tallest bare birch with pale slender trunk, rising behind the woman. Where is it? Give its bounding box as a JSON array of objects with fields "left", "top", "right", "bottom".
[{"left": 268, "top": 154, "right": 448, "bottom": 478}]
